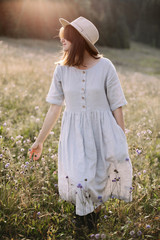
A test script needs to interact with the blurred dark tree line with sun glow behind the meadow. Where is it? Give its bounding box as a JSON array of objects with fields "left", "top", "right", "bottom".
[{"left": 0, "top": 0, "right": 160, "bottom": 48}]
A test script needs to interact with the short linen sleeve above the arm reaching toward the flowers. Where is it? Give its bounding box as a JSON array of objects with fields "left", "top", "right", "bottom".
[{"left": 46, "top": 65, "right": 64, "bottom": 105}]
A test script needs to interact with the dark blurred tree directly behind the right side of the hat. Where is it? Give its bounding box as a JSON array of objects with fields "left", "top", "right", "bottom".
[{"left": 83, "top": 0, "right": 130, "bottom": 48}]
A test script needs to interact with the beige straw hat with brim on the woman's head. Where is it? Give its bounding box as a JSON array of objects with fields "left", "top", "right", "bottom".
[{"left": 59, "top": 17, "right": 99, "bottom": 53}]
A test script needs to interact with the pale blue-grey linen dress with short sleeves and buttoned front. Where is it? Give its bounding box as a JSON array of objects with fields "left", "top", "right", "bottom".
[{"left": 46, "top": 57, "right": 132, "bottom": 216}]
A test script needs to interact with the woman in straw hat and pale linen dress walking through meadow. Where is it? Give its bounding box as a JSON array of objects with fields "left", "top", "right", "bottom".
[{"left": 30, "top": 17, "right": 132, "bottom": 231}]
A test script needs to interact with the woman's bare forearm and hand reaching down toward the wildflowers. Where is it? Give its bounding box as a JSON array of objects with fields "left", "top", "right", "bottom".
[{"left": 29, "top": 104, "right": 62, "bottom": 160}]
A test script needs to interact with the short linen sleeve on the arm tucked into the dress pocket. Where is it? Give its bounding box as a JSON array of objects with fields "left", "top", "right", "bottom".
[{"left": 106, "top": 61, "right": 127, "bottom": 111}]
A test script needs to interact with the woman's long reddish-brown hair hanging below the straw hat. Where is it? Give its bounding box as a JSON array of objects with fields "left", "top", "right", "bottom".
[{"left": 59, "top": 25, "right": 100, "bottom": 66}]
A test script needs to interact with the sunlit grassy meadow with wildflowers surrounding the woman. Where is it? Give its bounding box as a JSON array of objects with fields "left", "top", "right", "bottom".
[{"left": 0, "top": 37, "right": 160, "bottom": 240}]
